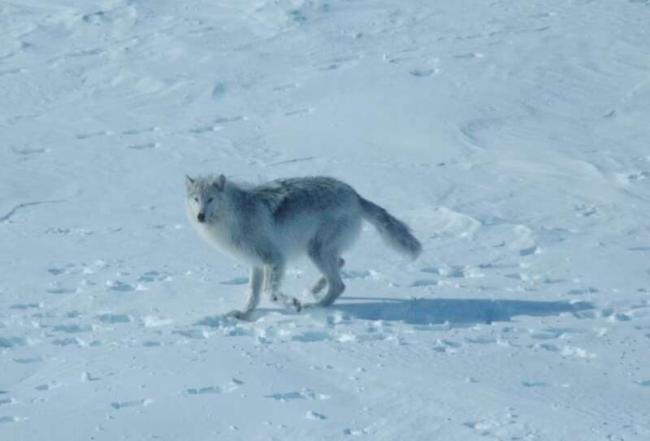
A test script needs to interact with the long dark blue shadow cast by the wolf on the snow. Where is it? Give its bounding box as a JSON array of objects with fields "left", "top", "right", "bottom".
[{"left": 331, "top": 297, "right": 593, "bottom": 326}]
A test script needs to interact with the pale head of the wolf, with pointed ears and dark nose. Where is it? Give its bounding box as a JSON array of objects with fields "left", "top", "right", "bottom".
[{"left": 185, "top": 175, "right": 226, "bottom": 224}]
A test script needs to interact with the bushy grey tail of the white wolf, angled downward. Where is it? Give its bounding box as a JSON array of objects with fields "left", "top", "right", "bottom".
[{"left": 359, "top": 196, "right": 422, "bottom": 259}]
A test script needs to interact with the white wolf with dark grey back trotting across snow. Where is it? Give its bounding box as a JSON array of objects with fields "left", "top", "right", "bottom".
[{"left": 186, "top": 175, "right": 422, "bottom": 319}]
